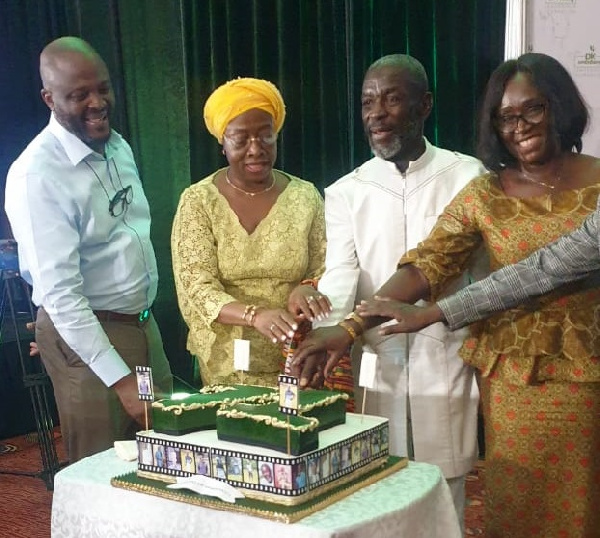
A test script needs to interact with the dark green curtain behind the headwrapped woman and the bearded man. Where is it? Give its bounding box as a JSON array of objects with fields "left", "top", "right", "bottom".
[{"left": 183, "top": 0, "right": 505, "bottom": 189}]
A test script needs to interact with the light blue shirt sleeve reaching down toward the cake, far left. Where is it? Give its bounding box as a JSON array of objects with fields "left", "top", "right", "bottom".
[{"left": 6, "top": 170, "right": 130, "bottom": 386}]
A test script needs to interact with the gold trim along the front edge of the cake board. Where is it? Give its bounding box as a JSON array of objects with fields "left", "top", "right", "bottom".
[{"left": 110, "top": 456, "right": 408, "bottom": 524}]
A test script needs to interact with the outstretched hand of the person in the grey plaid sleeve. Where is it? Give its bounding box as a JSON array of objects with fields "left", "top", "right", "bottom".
[{"left": 356, "top": 295, "right": 445, "bottom": 335}]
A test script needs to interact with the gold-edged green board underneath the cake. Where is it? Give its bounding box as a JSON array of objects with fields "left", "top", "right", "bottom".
[{"left": 110, "top": 456, "right": 408, "bottom": 523}]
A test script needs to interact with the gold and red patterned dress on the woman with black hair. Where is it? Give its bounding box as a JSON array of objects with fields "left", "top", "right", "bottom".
[{"left": 402, "top": 174, "right": 600, "bottom": 538}]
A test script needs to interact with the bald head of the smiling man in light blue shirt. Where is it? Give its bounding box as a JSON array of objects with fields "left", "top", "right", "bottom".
[{"left": 40, "top": 37, "right": 114, "bottom": 153}]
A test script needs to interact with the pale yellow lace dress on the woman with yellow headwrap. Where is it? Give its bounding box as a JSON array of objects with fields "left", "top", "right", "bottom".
[{"left": 171, "top": 172, "right": 325, "bottom": 385}]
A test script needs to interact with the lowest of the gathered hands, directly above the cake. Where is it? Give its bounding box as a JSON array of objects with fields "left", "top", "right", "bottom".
[{"left": 291, "top": 325, "right": 353, "bottom": 389}]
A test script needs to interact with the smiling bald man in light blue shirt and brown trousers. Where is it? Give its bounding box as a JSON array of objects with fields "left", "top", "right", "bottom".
[{"left": 6, "top": 37, "right": 171, "bottom": 461}]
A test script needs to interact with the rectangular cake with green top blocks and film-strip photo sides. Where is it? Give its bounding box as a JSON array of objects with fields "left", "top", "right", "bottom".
[{"left": 137, "top": 385, "right": 389, "bottom": 506}]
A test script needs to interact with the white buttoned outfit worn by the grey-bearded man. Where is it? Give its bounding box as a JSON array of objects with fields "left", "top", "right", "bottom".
[{"left": 319, "top": 140, "right": 486, "bottom": 478}]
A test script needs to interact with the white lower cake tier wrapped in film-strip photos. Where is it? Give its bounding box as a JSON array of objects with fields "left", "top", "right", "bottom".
[{"left": 137, "top": 413, "right": 388, "bottom": 505}]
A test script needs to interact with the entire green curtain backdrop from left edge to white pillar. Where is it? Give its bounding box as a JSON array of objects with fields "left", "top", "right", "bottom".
[{"left": 0, "top": 0, "right": 505, "bottom": 386}]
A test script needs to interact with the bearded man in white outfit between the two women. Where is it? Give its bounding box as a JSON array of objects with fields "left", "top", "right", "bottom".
[{"left": 294, "top": 54, "right": 484, "bottom": 524}]
